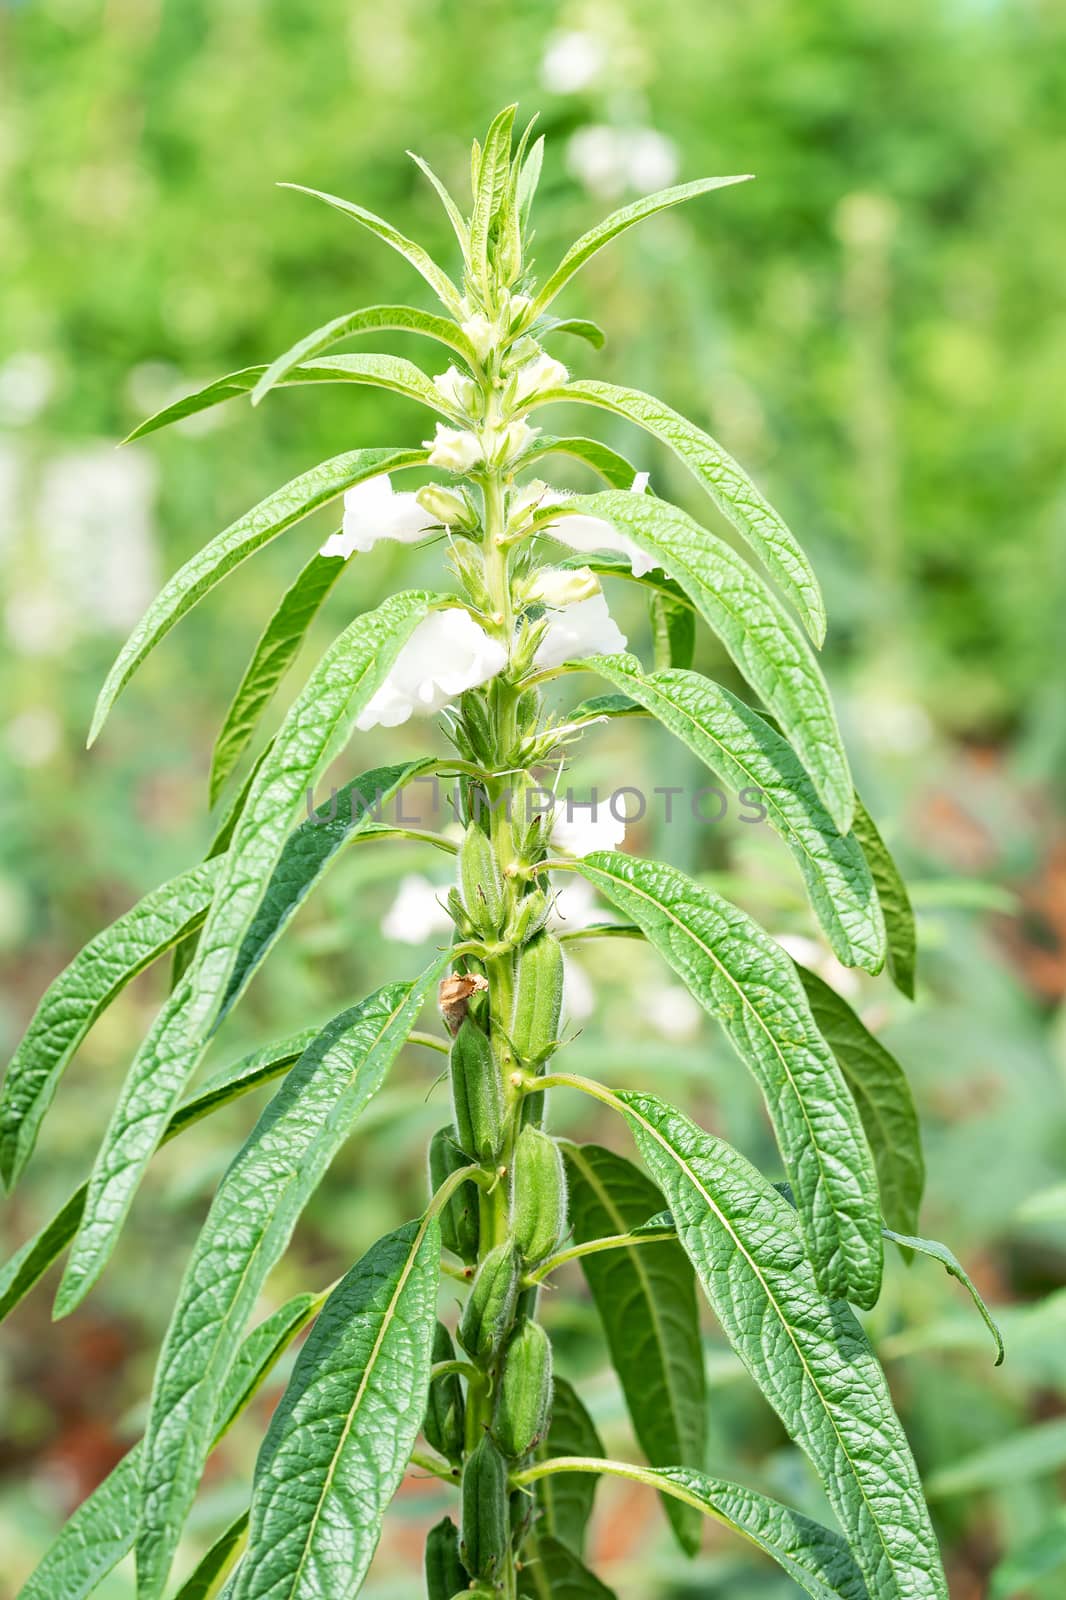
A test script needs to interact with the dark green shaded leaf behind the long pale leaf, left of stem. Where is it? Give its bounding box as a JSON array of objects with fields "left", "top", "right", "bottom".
[{"left": 219, "top": 757, "right": 437, "bottom": 1019}]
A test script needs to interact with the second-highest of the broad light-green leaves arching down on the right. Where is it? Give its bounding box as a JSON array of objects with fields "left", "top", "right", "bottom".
[{"left": 541, "top": 490, "right": 855, "bottom": 834}]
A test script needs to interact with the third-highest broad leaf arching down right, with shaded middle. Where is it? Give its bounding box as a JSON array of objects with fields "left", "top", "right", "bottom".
[{"left": 589, "top": 656, "right": 885, "bottom": 973}]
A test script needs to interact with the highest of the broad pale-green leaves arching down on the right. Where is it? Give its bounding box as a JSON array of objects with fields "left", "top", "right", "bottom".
[{"left": 550, "top": 379, "right": 826, "bottom": 645}]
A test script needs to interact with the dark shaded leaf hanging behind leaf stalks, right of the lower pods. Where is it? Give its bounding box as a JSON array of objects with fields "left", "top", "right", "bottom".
[{"left": 562, "top": 1144, "right": 706, "bottom": 1555}]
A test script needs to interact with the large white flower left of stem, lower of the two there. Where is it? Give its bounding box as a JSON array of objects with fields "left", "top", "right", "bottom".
[{"left": 355, "top": 606, "right": 507, "bottom": 733}]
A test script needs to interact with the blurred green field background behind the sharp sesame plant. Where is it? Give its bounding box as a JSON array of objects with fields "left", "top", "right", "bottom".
[{"left": 0, "top": 0, "right": 1066, "bottom": 1600}]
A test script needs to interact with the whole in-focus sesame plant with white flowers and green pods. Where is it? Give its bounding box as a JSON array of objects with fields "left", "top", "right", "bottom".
[{"left": 0, "top": 107, "right": 994, "bottom": 1600}]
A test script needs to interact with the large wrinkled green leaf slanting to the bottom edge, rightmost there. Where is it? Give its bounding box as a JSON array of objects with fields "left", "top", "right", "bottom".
[{"left": 616, "top": 1093, "right": 948, "bottom": 1600}]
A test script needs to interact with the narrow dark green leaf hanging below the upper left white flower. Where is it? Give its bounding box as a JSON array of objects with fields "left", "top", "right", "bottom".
[{"left": 210, "top": 552, "right": 349, "bottom": 805}]
